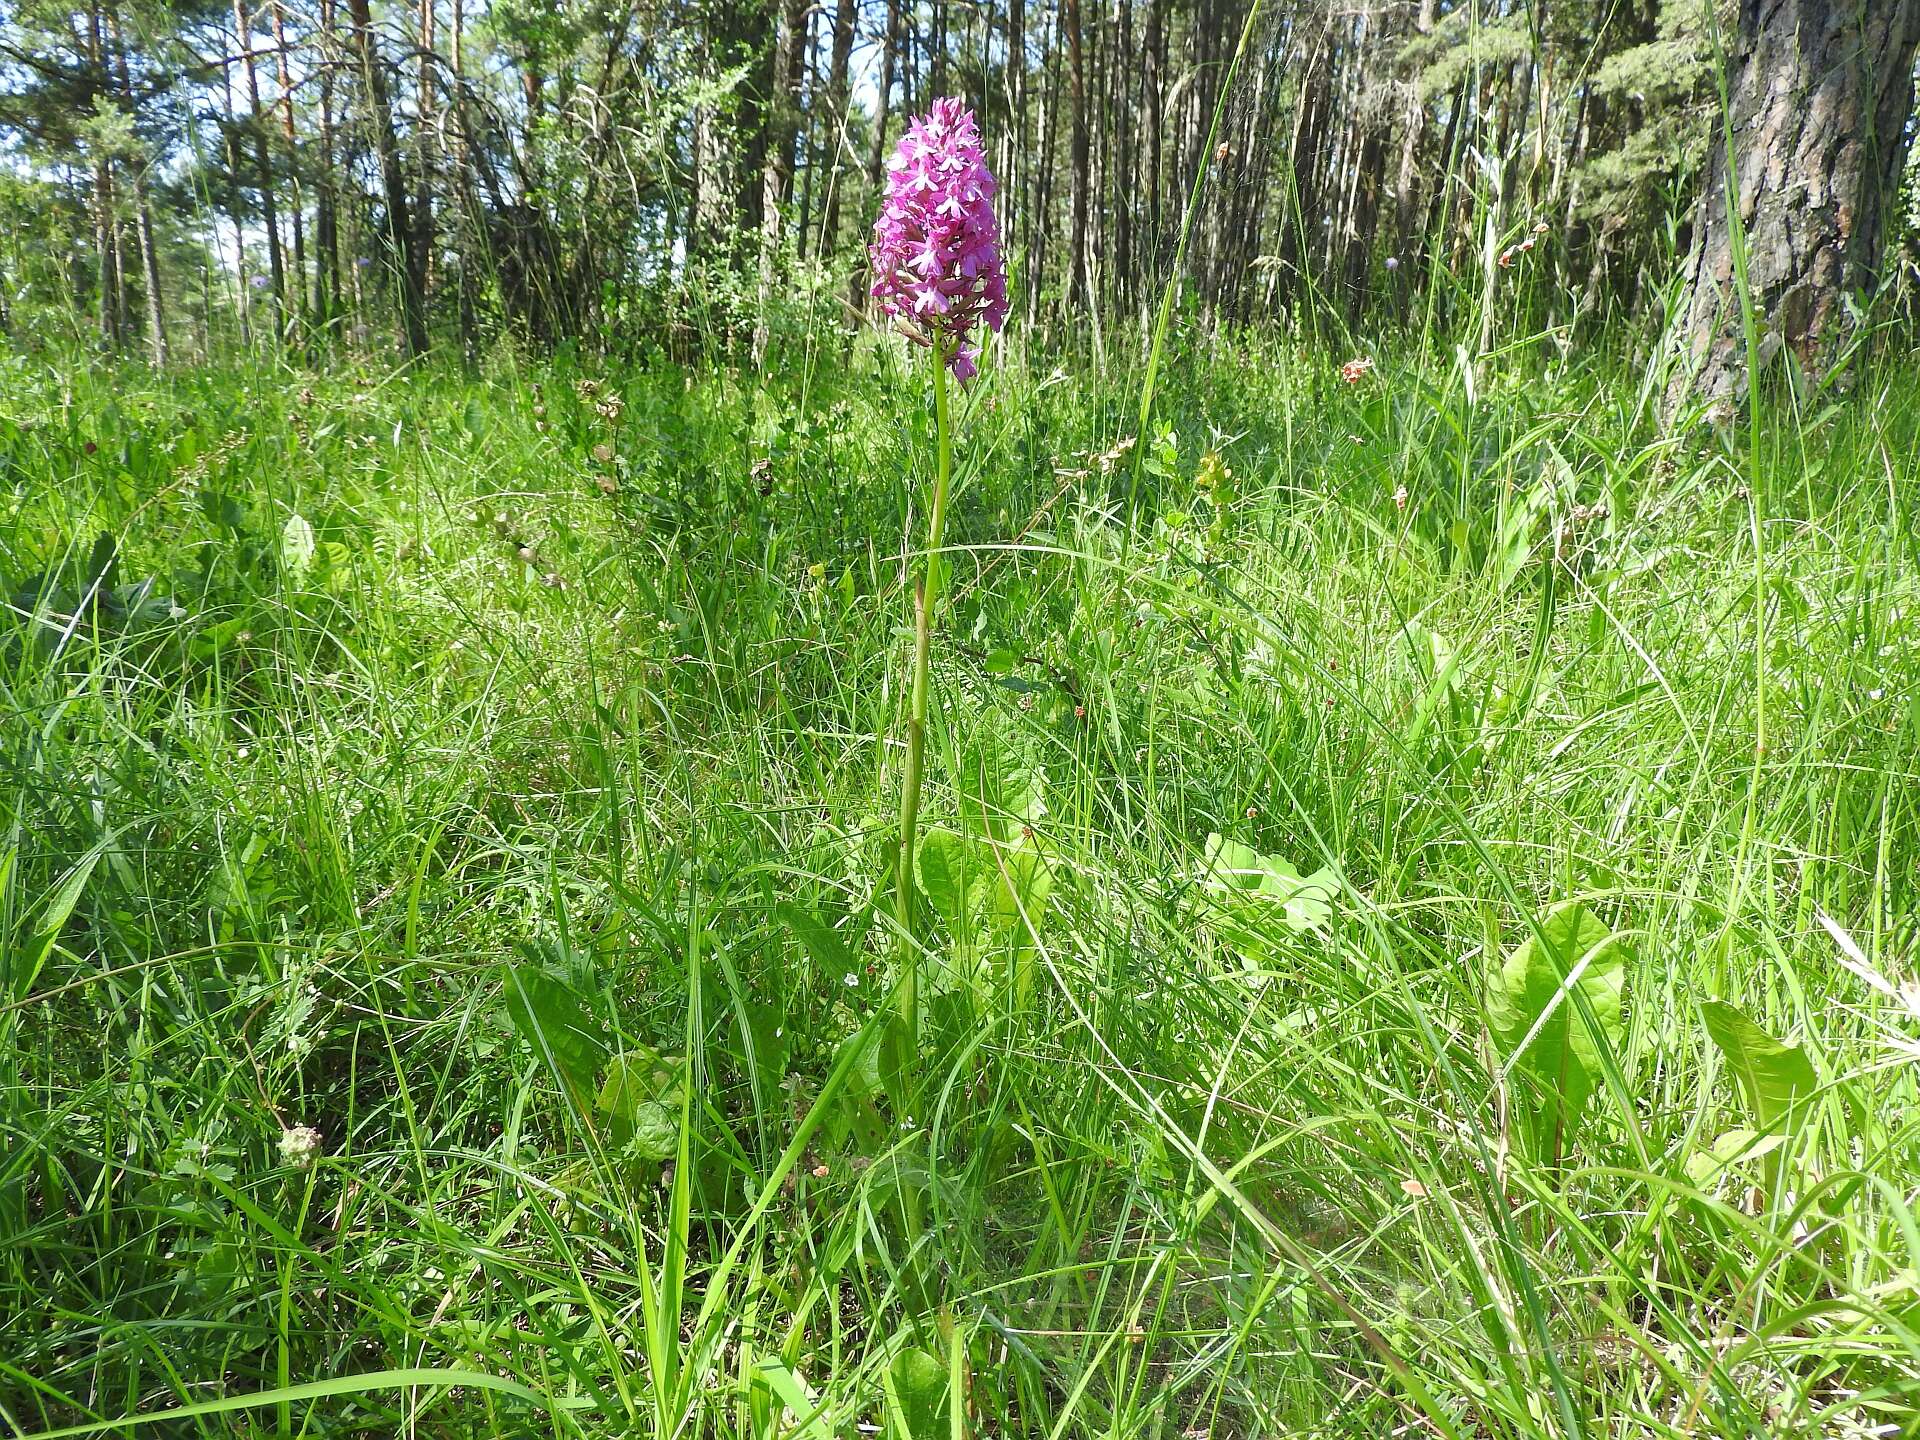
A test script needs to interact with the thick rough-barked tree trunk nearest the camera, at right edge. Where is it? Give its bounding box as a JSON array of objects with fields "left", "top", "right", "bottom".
[{"left": 1668, "top": 0, "right": 1920, "bottom": 403}]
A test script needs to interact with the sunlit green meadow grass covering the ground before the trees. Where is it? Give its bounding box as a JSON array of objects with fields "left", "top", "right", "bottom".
[{"left": 0, "top": 332, "right": 1920, "bottom": 1440}]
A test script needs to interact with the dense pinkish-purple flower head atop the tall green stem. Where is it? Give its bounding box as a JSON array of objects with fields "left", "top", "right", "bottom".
[{"left": 868, "top": 96, "right": 1006, "bottom": 382}]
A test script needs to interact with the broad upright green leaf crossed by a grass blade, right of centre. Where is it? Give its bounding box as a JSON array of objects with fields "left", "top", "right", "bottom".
[{"left": 1486, "top": 904, "right": 1626, "bottom": 1156}]
